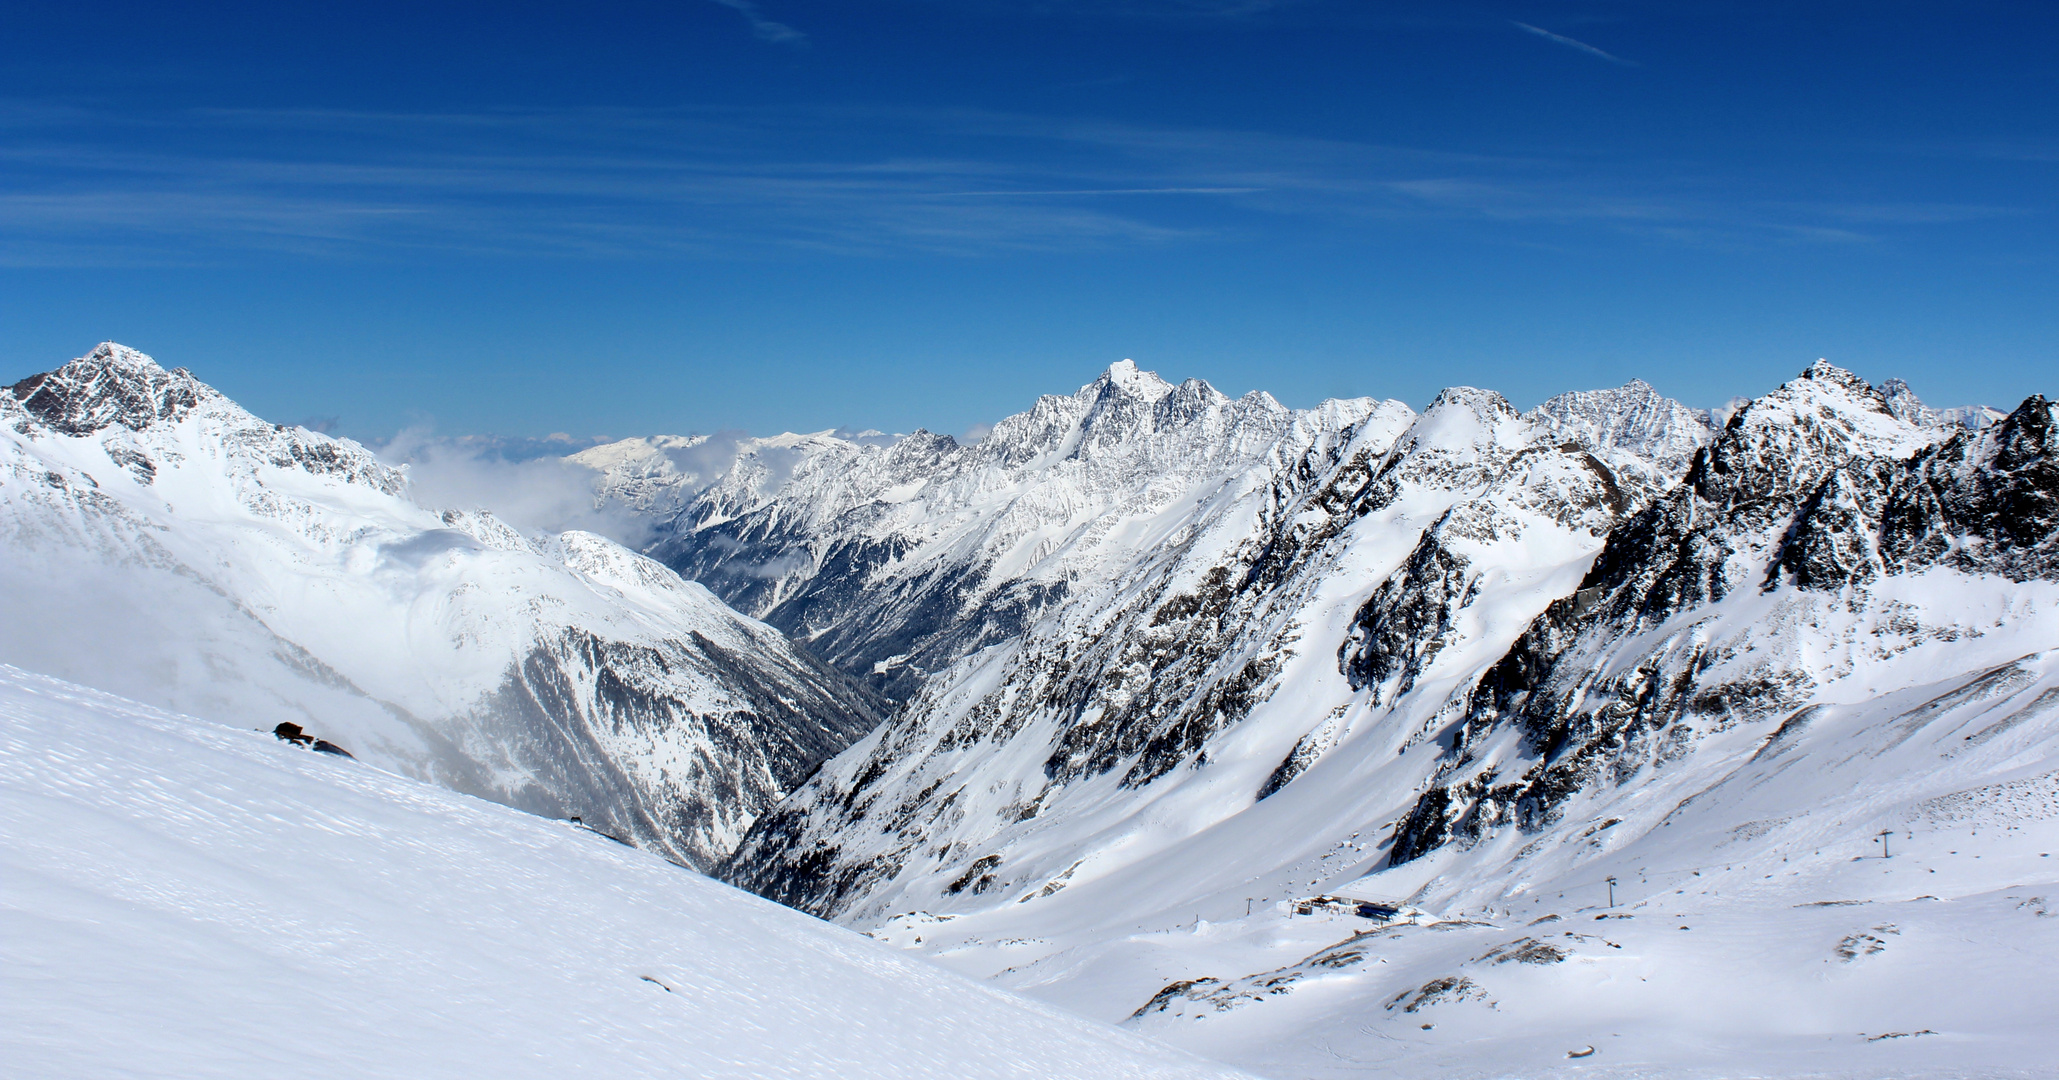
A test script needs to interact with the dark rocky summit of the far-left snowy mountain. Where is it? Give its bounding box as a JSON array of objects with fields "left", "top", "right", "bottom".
[{"left": 8, "top": 341, "right": 214, "bottom": 436}]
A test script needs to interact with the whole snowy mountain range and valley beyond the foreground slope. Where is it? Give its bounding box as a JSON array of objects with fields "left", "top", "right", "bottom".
[{"left": 0, "top": 344, "right": 2059, "bottom": 1078}]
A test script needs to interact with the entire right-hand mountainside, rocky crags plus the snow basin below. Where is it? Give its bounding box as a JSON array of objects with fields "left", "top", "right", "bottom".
[{"left": 723, "top": 364, "right": 2059, "bottom": 1076}]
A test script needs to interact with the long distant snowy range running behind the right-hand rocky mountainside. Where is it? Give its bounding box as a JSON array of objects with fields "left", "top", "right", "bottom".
[{"left": 601, "top": 360, "right": 1991, "bottom": 699}]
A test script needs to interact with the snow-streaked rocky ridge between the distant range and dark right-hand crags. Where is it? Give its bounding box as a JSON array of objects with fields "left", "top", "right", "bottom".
[{"left": 723, "top": 376, "right": 1670, "bottom": 922}]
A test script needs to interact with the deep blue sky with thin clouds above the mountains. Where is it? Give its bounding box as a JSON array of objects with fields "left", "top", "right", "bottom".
[{"left": 0, "top": 0, "right": 2059, "bottom": 438}]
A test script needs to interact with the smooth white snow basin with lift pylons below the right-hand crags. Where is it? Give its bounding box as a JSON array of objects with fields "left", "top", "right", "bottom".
[{"left": 893, "top": 572, "right": 2059, "bottom": 1078}]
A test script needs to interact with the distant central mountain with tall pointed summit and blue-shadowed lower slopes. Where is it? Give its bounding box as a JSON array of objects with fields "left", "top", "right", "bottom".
[{"left": 630, "top": 360, "right": 1334, "bottom": 699}]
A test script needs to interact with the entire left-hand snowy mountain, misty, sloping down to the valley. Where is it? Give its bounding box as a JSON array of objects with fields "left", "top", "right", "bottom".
[{"left": 0, "top": 344, "right": 877, "bottom": 864}]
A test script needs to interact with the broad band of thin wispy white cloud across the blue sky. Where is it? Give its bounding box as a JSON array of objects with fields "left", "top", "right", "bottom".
[{"left": 0, "top": 105, "right": 2008, "bottom": 265}]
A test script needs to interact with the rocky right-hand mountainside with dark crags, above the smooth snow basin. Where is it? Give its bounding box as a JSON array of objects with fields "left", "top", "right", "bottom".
[{"left": 721, "top": 364, "right": 2051, "bottom": 938}]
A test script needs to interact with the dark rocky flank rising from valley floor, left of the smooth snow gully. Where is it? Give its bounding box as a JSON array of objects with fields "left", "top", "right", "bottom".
[{"left": 723, "top": 394, "right": 1402, "bottom": 915}]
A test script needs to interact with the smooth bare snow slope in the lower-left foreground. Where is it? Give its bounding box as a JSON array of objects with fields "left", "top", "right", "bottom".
[{"left": 0, "top": 667, "right": 1233, "bottom": 1080}]
